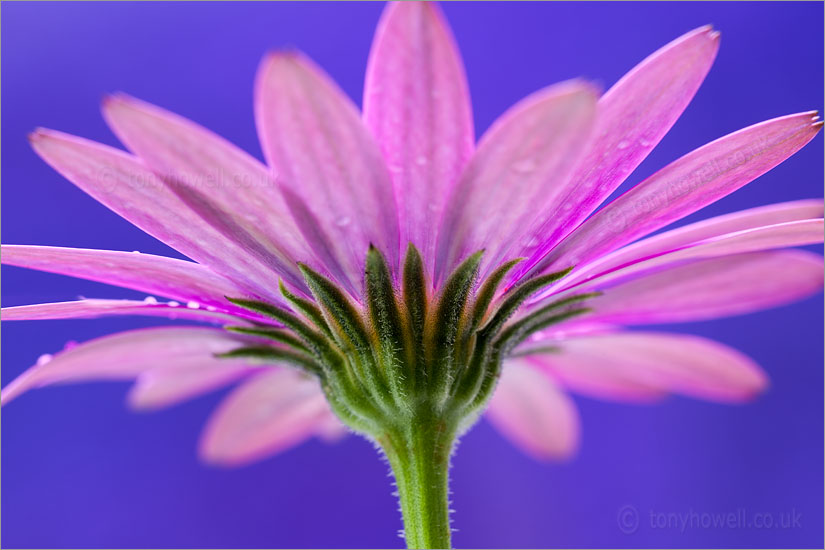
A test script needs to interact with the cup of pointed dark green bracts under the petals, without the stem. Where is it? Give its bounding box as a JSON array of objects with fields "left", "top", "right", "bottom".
[{"left": 222, "top": 244, "right": 595, "bottom": 442}]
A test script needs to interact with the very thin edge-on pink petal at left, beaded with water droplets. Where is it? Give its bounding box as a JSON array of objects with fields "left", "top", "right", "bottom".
[{"left": 2, "top": 298, "right": 239, "bottom": 324}]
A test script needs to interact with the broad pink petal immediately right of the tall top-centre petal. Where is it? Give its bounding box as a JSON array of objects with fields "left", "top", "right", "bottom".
[{"left": 436, "top": 81, "right": 598, "bottom": 276}]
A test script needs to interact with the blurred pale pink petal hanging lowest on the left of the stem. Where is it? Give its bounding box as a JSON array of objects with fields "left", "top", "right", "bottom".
[{"left": 200, "top": 368, "right": 329, "bottom": 466}]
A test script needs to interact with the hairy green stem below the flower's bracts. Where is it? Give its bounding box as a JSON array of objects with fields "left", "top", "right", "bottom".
[{"left": 379, "top": 414, "right": 455, "bottom": 548}]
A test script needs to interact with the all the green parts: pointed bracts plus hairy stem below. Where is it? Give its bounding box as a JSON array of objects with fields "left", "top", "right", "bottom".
[{"left": 221, "top": 249, "right": 598, "bottom": 548}]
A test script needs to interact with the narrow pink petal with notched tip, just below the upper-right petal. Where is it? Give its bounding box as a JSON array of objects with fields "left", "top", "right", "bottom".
[{"left": 541, "top": 113, "right": 822, "bottom": 274}]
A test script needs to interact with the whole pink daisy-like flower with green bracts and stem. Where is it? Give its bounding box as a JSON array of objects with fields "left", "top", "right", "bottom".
[{"left": 2, "top": 2, "right": 823, "bottom": 547}]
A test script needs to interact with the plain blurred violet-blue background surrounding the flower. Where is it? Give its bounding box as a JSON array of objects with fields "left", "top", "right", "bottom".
[{"left": 2, "top": 2, "right": 823, "bottom": 547}]
